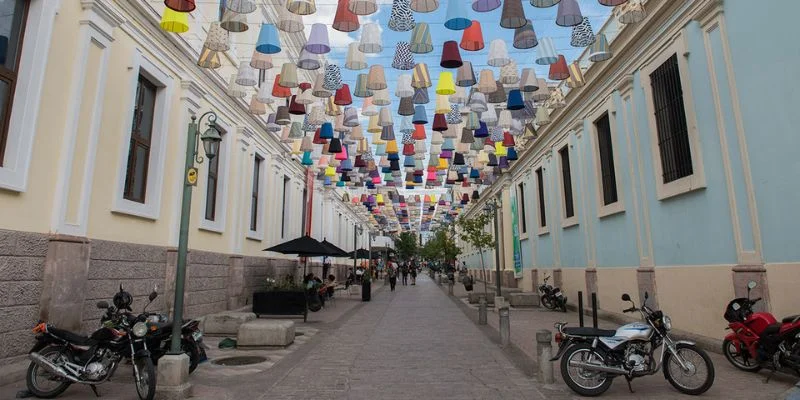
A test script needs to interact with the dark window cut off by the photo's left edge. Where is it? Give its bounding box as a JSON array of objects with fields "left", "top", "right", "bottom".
[{"left": 0, "top": 0, "right": 29, "bottom": 166}]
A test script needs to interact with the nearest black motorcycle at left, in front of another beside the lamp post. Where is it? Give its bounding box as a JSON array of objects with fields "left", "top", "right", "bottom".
[{"left": 25, "top": 285, "right": 158, "bottom": 400}]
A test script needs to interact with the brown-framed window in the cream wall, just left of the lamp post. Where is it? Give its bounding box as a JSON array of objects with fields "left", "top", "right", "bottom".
[{"left": 123, "top": 75, "right": 158, "bottom": 203}]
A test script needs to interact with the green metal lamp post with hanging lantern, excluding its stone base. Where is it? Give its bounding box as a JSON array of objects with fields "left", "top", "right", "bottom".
[{"left": 170, "top": 111, "right": 222, "bottom": 354}]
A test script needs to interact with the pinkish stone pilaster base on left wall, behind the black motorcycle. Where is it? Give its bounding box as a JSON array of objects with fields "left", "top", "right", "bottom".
[{"left": 39, "top": 235, "right": 91, "bottom": 332}]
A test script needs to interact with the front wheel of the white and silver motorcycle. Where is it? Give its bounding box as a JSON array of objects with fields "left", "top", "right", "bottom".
[{"left": 663, "top": 343, "right": 714, "bottom": 396}]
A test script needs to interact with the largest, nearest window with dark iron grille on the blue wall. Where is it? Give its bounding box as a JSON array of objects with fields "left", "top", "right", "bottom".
[{"left": 650, "top": 54, "right": 693, "bottom": 183}]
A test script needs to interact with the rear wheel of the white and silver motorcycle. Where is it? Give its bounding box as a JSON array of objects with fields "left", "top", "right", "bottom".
[{"left": 561, "top": 343, "right": 614, "bottom": 396}]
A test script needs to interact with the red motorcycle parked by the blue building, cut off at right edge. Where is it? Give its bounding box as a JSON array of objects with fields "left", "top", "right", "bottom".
[{"left": 722, "top": 281, "right": 800, "bottom": 374}]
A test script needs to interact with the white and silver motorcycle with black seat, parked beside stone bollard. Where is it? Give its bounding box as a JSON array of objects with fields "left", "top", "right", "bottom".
[{"left": 551, "top": 292, "right": 714, "bottom": 396}]
